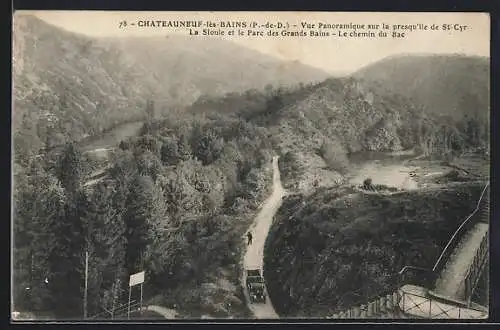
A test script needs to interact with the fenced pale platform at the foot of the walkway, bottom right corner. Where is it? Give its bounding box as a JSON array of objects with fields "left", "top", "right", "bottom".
[{"left": 328, "top": 285, "right": 488, "bottom": 319}]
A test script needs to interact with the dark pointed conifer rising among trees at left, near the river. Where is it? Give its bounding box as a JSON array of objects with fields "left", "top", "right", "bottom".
[{"left": 56, "top": 142, "right": 82, "bottom": 194}]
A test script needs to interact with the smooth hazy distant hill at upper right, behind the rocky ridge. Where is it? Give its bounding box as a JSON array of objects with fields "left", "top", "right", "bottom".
[{"left": 353, "top": 55, "right": 490, "bottom": 120}]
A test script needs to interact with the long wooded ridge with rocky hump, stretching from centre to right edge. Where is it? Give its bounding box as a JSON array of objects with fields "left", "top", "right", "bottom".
[{"left": 191, "top": 72, "right": 488, "bottom": 159}]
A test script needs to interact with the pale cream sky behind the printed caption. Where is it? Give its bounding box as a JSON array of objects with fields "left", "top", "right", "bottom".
[{"left": 18, "top": 11, "right": 490, "bottom": 73}]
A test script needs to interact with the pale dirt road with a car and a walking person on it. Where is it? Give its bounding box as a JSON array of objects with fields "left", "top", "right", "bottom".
[{"left": 243, "top": 156, "right": 285, "bottom": 319}]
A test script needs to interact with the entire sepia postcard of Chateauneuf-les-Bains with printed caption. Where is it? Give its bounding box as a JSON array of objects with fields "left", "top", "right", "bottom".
[{"left": 10, "top": 10, "right": 491, "bottom": 323}]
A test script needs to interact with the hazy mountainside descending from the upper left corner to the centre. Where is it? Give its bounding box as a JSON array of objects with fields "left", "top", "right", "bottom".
[{"left": 13, "top": 15, "right": 328, "bottom": 164}]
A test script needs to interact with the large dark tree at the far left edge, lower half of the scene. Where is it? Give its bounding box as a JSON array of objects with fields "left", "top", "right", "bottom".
[{"left": 13, "top": 165, "right": 66, "bottom": 310}]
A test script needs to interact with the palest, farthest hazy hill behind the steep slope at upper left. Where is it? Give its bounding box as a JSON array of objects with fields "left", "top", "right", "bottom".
[{"left": 105, "top": 36, "right": 329, "bottom": 105}]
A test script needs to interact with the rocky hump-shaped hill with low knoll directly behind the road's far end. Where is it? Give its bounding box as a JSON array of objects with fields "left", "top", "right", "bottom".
[{"left": 254, "top": 78, "right": 446, "bottom": 192}]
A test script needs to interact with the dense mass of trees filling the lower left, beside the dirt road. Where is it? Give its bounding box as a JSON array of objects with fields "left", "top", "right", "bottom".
[{"left": 14, "top": 111, "right": 271, "bottom": 317}]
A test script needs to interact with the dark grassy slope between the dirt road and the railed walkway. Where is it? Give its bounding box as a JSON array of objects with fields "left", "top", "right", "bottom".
[{"left": 265, "top": 185, "right": 482, "bottom": 316}]
